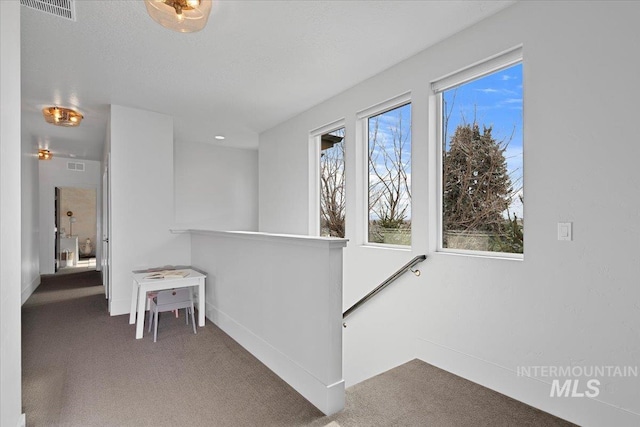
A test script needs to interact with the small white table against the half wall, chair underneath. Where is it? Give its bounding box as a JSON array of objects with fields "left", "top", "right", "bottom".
[{"left": 129, "top": 268, "right": 207, "bottom": 339}]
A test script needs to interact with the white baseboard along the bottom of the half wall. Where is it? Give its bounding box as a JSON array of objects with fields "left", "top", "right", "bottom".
[{"left": 205, "top": 302, "right": 345, "bottom": 415}]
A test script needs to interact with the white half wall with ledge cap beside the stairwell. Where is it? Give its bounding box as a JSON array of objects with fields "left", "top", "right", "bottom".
[{"left": 191, "top": 230, "right": 346, "bottom": 415}]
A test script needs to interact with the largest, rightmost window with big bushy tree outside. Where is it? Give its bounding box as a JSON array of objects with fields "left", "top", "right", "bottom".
[{"left": 434, "top": 50, "right": 524, "bottom": 254}]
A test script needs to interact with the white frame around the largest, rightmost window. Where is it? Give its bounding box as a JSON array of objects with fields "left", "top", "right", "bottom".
[{"left": 430, "top": 45, "right": 525, "bottom": 261}]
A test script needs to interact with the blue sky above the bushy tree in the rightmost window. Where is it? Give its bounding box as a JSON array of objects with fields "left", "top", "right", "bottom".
[{"left": 443, "top": 64, "right": 523, "bottom": 218}]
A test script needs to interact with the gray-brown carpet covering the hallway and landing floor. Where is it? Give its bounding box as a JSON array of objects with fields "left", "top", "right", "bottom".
[{"left": 22, "top": 272, "right": 570, "bottom": 427}]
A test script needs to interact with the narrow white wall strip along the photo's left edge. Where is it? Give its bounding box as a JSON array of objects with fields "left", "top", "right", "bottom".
[{"left": 0, "top": 1, "right": 22, "bottom": 427}]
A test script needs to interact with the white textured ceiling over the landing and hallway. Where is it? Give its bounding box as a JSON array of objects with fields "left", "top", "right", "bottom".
[{"left": 21, "top": 0, "right": 513, "bottom": 160}]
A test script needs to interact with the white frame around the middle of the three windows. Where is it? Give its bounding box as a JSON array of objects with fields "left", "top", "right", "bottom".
[{"left": 356, "top": 91, "right": 414, "bottom": 250}]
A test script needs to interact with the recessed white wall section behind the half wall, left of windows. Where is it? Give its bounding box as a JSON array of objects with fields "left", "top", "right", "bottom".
[{"left": 174, "top": 141, "right": 258, "bottom": 231}]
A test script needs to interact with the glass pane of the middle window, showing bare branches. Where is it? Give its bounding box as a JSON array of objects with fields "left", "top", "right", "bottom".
[{"left": 368, "top": 104, "right": 411, "bottom": 246}]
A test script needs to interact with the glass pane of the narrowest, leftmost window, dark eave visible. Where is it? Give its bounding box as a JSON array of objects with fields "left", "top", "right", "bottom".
[{"left": 320, "top": 128, "right": 345, "bottom": 237}]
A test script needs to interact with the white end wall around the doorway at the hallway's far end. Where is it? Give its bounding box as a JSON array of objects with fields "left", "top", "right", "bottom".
[{"left": 39, "top": 157, "right": 102, "bottom": 278}]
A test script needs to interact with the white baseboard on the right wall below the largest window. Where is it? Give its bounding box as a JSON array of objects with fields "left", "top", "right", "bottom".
[{"left": 416, "top": 339, "right": 640, "bottom": 427}]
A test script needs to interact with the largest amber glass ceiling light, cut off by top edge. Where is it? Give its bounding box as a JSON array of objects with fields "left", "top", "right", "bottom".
[{"left": 144, "top": 0, "right": 211, "bottom": 33}]
